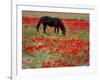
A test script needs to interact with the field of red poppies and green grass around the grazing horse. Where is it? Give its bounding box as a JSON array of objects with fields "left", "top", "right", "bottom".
[{"left": 22, "top": 12, "right": 90, "bottom": 69}]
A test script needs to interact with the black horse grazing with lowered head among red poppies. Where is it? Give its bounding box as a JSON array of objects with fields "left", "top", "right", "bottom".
[{"left": 36, "top": 16, "right": 65, "bottom": 35}]
